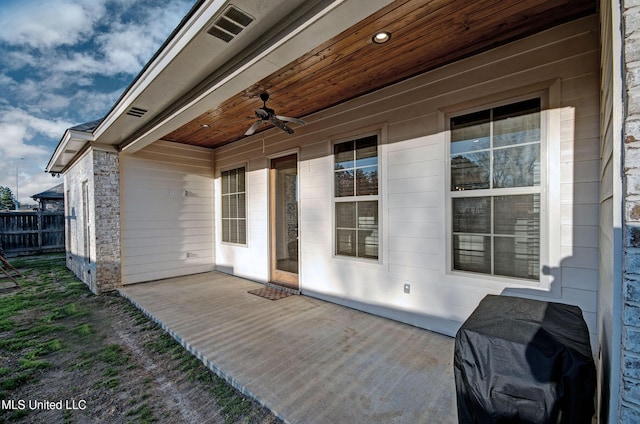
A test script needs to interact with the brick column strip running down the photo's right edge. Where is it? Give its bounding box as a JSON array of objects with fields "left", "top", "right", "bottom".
[{"left": 620, "top": 0, "right": 640, "bottom": 423}]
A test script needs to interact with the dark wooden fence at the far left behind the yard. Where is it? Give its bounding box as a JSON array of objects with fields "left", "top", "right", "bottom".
[{"left": 0, "top": 211, "right": 64, "bottom": 256}]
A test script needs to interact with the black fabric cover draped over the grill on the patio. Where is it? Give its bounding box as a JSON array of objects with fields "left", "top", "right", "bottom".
[{"left": 454, "top": 295, "right": 596, "bottom": 424}]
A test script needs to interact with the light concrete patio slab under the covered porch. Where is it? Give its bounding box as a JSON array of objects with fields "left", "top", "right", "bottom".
[{"left": 120, "top": 272, "right": 457, "bottom": 424}]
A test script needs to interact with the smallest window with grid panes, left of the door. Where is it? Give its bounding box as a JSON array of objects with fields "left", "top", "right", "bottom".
[{"left": 221, "top": 167, "right": 247, "bottom": 244}]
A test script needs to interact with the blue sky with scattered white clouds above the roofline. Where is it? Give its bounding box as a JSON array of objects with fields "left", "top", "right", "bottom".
[{"left": 0, "top": 0, "right": 195, "bottom": 204}]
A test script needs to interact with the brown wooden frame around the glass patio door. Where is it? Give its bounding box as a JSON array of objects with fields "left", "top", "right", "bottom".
[{"left": 267, "top": 149, "right": 300, "bottom": 291}]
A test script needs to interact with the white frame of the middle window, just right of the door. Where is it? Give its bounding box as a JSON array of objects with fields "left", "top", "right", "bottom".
[{"left": 330, "top": 132, "right": 383, "bottom": 264}]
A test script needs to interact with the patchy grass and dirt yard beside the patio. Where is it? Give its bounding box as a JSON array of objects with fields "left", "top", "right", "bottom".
[{"left": 0, "top": 255, "right": 281, "bottom": 424}]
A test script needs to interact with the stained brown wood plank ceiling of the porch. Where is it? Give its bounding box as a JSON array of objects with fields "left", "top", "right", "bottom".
[{"left": 162, "top": 0, "right": 596, "bottom": 148}]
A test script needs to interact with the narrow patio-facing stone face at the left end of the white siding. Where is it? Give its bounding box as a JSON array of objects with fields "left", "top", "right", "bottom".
[{"left": 93, "top": 150, "right": 121, "bottom": 292}]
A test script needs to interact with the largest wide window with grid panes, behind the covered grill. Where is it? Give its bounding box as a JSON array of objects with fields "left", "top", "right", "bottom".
[{"left": 449, "top": 98, "right": 543, "bottom": 281}]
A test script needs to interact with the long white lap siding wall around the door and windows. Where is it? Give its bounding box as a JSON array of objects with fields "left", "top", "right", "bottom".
[{"left": 216, "top": 17, "right": 599, "bottom": 335}]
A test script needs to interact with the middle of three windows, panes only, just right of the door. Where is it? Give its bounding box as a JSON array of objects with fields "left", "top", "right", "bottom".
[{"left": 333, "top": 135, "right": 379, "bottom": 259}]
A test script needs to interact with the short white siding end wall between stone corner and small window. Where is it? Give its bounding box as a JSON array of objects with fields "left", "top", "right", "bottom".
[{"left": 121, "top": 141, "right": 214, "bottom": 284}]
